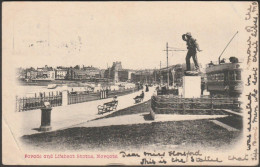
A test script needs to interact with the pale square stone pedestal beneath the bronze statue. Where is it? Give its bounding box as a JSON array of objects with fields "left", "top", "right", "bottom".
[{"left": 183, "top": 76, "right": 201, "bottom": 98}]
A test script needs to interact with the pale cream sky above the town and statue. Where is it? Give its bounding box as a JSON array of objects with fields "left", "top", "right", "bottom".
[{"left": 3, "top": 2, "right": 249, "bottom": 69}]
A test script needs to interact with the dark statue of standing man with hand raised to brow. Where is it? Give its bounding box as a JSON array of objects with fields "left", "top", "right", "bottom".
[{"left": 182, "top": 32, "right": 202, "bottom": 71}]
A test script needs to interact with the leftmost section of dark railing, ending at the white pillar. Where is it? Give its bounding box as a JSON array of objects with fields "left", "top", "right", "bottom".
[{"left": 16, "top": 95, "right": 62, "bottom": 112}]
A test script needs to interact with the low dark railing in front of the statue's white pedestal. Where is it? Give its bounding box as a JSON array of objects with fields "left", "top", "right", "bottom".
[{"left": 151, "top": 96, "right": 241, "bottom": 113}]
